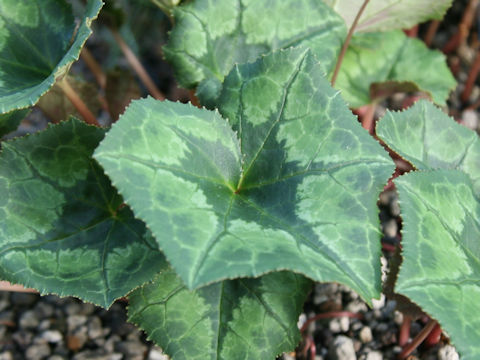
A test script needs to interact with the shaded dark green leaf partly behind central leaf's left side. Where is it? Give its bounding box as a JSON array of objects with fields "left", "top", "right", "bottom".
[{"left": 0, "top": 119, "right": 164, "bottom": 306}]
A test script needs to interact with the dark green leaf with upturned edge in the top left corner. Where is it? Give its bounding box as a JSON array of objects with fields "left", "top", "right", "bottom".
[{"left": 0, "top": 0, "right": 102, "bottom": 113}]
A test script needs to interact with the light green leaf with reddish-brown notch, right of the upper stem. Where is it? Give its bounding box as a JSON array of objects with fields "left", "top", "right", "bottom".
[{"left": 336, "top": 31, "right": 456, "bottom": 108}]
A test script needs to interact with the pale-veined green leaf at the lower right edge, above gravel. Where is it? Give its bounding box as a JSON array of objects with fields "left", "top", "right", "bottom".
[{"left": 395, "top": 171, "right": 480, "bottom": 360}]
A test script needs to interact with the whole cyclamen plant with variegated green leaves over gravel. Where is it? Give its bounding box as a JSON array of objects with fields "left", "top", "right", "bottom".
[{"left": 0, "top": 0, "right": 480, "bottom": 360}]
